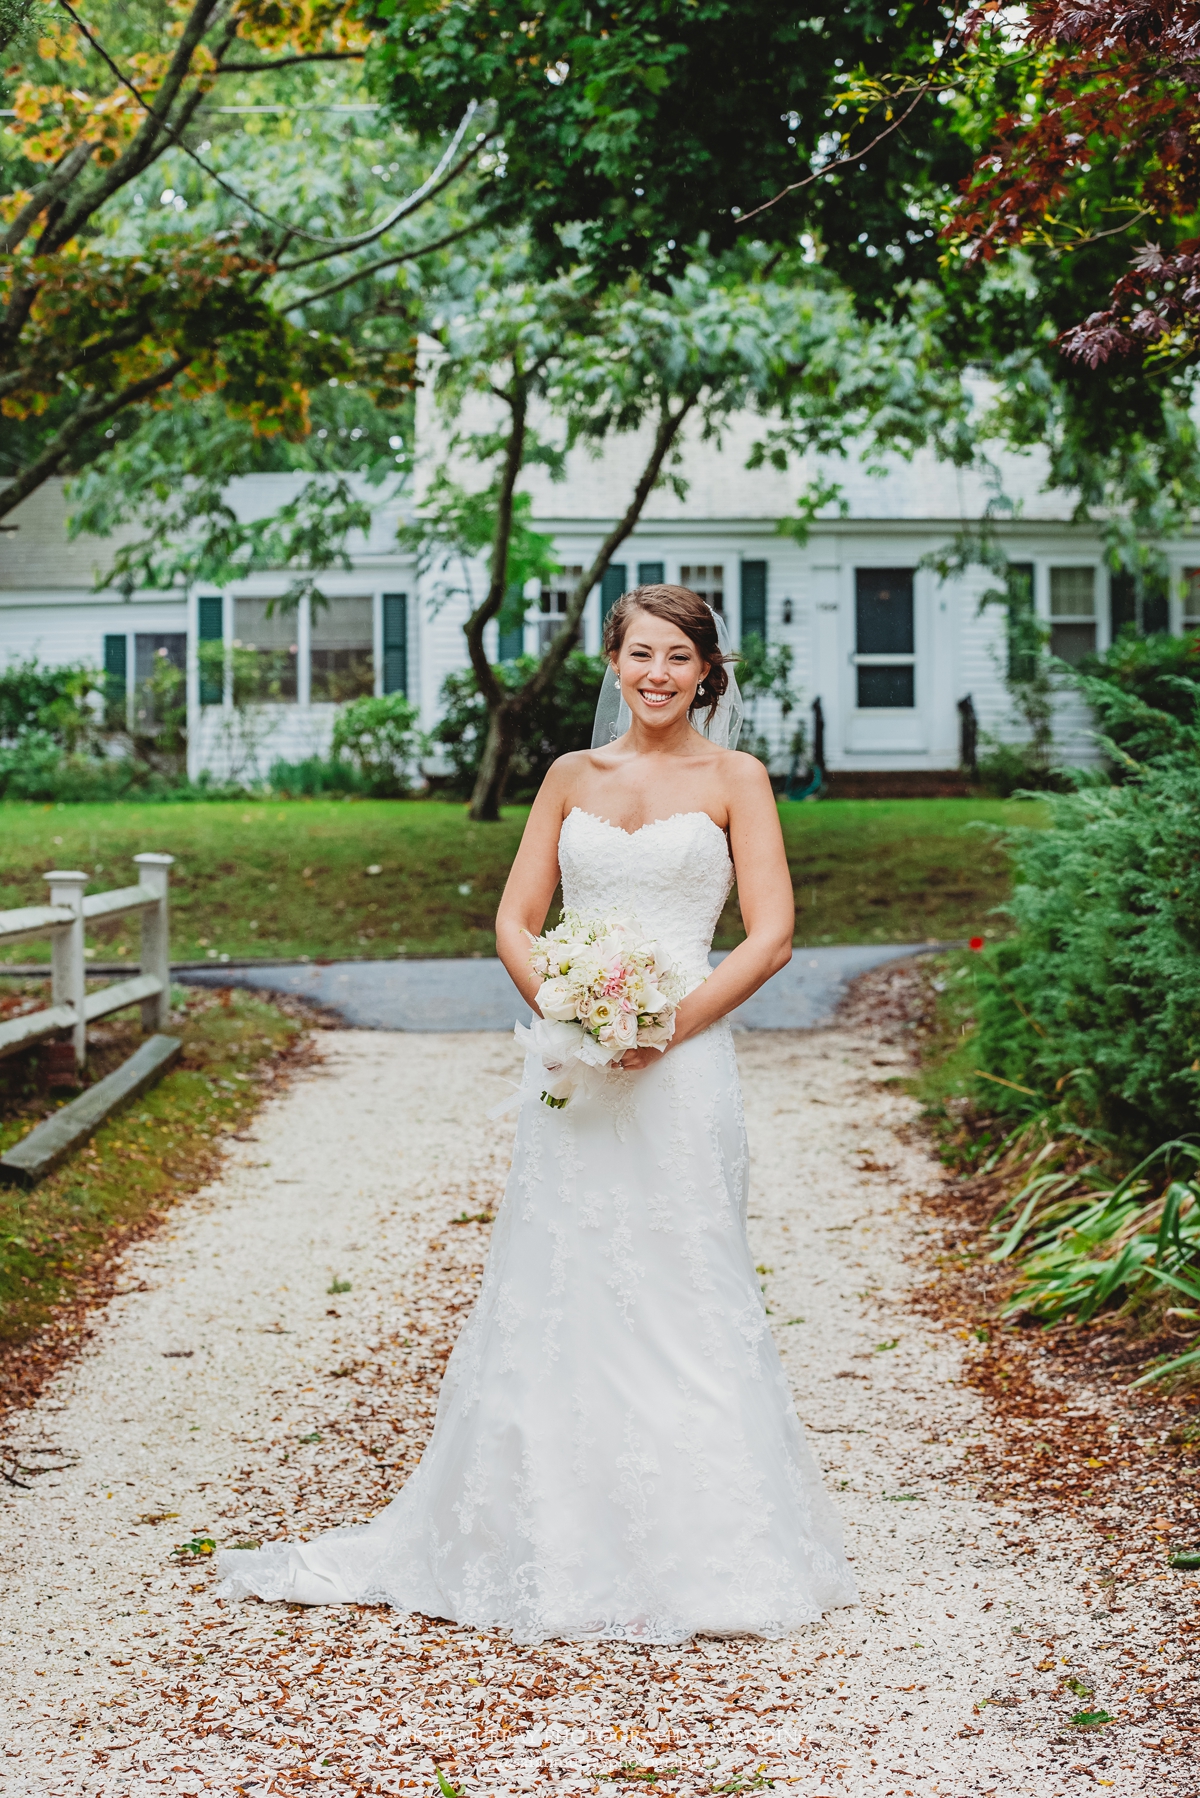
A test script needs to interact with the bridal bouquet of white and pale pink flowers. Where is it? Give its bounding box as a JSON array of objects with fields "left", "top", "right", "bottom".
[{"left": 518, "top": 912, "right": 687, "bottom": 1108}]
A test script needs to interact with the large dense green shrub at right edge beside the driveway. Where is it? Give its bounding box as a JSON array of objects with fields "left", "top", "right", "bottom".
[{"left": 975, "top": 729, "right": 1200, "bottom": 1153}]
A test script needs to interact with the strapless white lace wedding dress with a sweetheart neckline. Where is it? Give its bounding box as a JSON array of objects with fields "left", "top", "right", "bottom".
[{"left": 221, "top": 811, "right": 856, "bottom": 1642}]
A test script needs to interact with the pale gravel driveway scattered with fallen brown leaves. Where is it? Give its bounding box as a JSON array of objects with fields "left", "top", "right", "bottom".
[{"left": 0, "top": 1030, "right": 1195, "bottom": 1798}]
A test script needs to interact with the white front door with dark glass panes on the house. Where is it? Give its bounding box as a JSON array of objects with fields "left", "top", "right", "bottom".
[{"left": 842, "top": 568, "right": 928, "bottom": 755}]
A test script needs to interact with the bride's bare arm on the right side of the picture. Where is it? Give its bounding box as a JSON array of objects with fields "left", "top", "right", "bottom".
[{"left": 621, "top": 755, "right": 795, "bottom": 1068}]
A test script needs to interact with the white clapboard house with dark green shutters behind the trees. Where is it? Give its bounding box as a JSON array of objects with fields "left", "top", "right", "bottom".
[{"left": 0, "top": 419, "right": 1200, "bottom": 780}]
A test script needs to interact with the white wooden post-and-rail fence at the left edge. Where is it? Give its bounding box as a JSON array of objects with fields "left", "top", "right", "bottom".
[{"left": 0, "top": 854, "right": 175, "bottom": 1068}]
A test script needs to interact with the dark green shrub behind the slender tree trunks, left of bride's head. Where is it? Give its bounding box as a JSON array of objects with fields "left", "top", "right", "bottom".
[{"left": 430, "top": 649, "right": 606, "bottom": 800}]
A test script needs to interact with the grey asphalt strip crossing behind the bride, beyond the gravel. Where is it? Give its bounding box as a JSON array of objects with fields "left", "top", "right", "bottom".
[{"left": 175, "top": 942, "right": 941, "bottom": 1030}]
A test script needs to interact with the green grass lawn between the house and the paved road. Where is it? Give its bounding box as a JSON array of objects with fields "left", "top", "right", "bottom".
[{"left": 0, "top": 798, "right": 1040, "bottom": 962}]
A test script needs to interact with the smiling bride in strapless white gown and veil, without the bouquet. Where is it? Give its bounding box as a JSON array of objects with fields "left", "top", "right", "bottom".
[{"left": 219, "top": 586, "right": 856, "bottom": 1642}]
